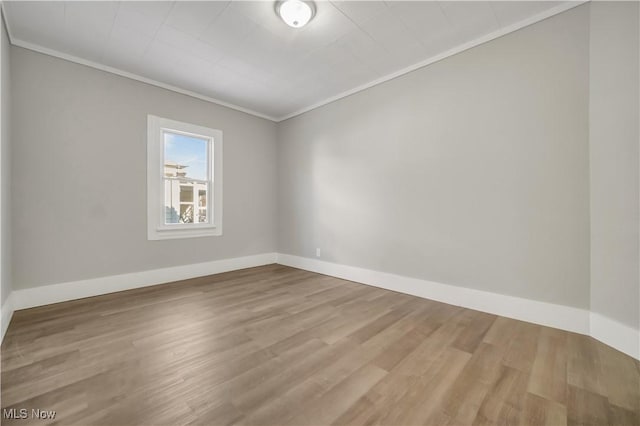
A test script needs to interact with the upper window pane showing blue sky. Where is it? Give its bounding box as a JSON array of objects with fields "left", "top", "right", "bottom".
[{"left": 163, "top": 131, "right": 209, "bottom": 180}]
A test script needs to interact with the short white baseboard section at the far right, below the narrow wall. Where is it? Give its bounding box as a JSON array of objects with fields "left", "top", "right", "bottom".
[{"left": 590, "top": 312, "right": 640, "bottom": 360}]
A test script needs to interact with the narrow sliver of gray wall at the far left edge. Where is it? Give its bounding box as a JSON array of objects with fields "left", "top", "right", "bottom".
[{"left": 0, "top": 12, "right": 12, "bottom": 305}]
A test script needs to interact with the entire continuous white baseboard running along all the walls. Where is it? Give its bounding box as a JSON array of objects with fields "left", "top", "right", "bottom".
[{"left": 0, "top": 253, "right": 640, "bottom": 359}]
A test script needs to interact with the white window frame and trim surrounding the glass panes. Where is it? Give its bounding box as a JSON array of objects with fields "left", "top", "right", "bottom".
[{"left": 147, "top": 115, "right": 222, "bottom": 240}]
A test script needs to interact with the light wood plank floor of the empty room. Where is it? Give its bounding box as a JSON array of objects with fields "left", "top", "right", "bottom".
[{"left": 2, "top": 265, "right": 640, "bottom": 425}]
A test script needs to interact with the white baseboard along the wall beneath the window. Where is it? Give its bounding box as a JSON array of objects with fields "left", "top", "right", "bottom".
[{"left": 11, "top": 253, "right": 278, "bottom": 314}]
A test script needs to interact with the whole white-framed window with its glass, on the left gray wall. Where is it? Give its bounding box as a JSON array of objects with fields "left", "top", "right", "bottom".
[{"left": 147, "top": 115, "right": 222, "bottom": 240}]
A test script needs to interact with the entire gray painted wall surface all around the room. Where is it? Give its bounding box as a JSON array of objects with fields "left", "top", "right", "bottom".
[{"left": 8, "top": 3, "right": 640, "bottom": 327}]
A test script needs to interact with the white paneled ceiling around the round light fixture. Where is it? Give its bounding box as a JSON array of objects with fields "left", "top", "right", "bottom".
[{"left": 3, "top": 0, "right": 579, "bottom": 121}]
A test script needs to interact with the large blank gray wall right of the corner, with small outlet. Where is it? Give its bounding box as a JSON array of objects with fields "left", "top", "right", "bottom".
[{"left": 278, "top": 6, "right": 589, "bottom": 308}]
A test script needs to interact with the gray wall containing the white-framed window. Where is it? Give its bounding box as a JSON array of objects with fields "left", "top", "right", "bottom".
[{"left": 11, "top": 47, "right": 277, "bottom": 289}]
